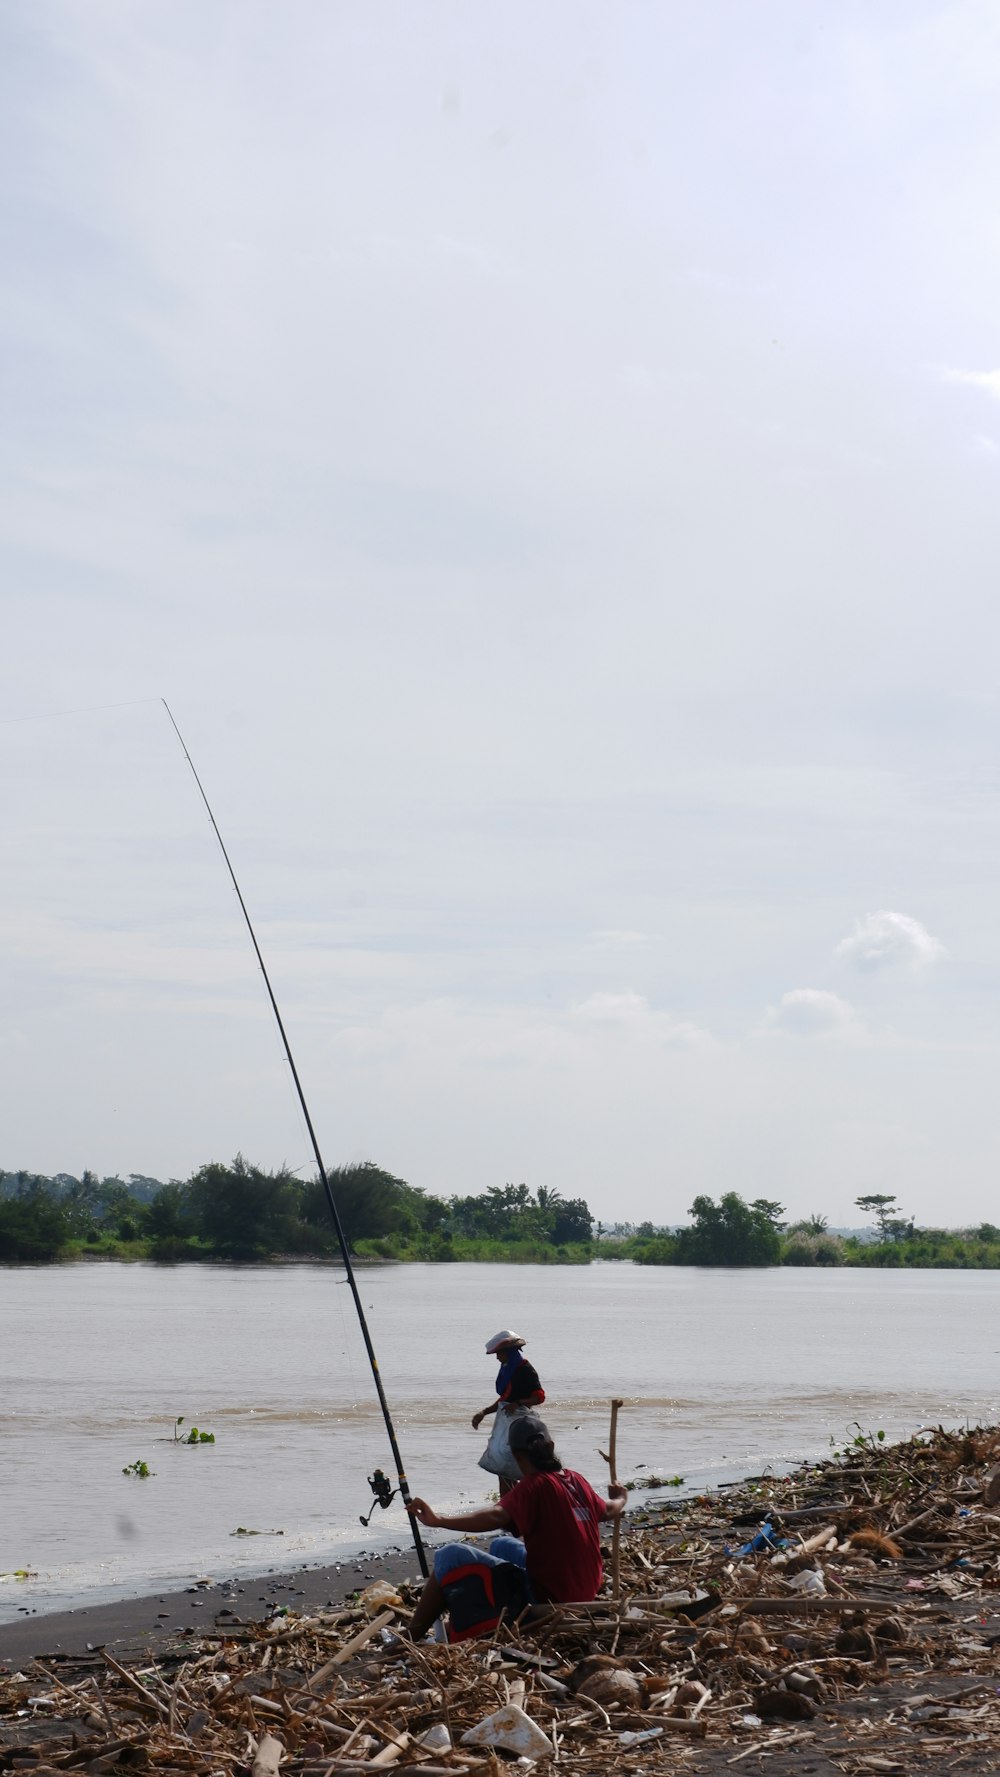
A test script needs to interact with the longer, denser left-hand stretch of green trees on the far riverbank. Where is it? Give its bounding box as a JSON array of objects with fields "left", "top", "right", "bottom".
[{"left": 0, "top": 1153, "right": 593, "bottom": 1263}]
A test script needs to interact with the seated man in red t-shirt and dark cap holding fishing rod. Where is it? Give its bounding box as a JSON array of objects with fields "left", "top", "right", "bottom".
[{"left": 410, "top": 1413, "right": 627, "bottom": 1640}]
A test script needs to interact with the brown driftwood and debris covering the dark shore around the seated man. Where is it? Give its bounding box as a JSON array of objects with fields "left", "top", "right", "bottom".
[{"left": 0, "top": 1429, "right": 1000, "bottom": 1777}]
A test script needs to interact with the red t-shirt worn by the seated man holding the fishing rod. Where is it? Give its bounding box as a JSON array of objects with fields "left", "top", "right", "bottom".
[{"left": 501, "top": 1468, "right": 607, "bottom": 1605}]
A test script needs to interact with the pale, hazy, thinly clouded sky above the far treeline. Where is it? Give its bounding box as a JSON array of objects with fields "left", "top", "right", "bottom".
[{"left": 0, "top": 0, "right": 1000, "bottom": 1226}]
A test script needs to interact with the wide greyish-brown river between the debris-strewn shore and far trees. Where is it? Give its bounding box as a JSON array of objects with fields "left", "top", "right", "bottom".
[{"left": 0, "top": 1263, "right": 1000, "bottom": 1622}]
